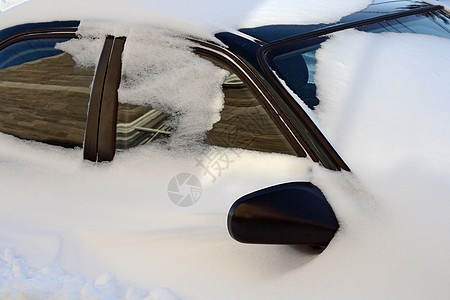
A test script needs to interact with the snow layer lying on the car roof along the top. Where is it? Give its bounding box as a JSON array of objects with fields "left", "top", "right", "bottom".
[{"left": 0, "top": 0, "right": 372, "bottom": 37}]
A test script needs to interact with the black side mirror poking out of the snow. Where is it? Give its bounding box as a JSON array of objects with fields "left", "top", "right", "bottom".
[{"left": 228, "top": 182, "right": 339, "bottom": 246}]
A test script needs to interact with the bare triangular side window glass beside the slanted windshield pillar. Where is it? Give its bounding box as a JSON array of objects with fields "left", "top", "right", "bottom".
[{"left": 202, "top": 56, "right": 297, "bottom": 156}]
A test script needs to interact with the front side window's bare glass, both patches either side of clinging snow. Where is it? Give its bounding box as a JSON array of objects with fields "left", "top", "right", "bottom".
[{"left": 116, "top": 53, "right": 297, "bottom": 155}]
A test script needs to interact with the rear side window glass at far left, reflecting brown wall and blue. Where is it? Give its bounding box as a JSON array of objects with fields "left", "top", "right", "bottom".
[{"left": 0, "top": 38, "right": 94, "bottom": 147}]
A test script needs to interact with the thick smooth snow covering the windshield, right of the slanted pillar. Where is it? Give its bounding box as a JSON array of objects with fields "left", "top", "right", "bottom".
[{"left": 315, "top": 30, "right": 450, "bottom": 179}]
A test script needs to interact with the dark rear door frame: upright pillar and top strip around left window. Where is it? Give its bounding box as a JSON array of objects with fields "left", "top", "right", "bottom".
[{"left": 0, "top": 21, "right": 126, "bottom": 161}]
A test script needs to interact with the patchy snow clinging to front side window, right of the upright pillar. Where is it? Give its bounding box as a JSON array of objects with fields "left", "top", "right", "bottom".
[{"left": 119, "top": 28, "right": 229, "bottom": 146}]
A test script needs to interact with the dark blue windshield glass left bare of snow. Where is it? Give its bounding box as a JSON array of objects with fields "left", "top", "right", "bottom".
[{"left": 268, "top": 10, "right": 450, "bottom": 109}]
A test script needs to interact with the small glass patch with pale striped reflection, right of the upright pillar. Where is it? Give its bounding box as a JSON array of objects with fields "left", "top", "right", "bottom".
[{"left": 116, "top": 103, "right": 172, "bottom": 150}]
